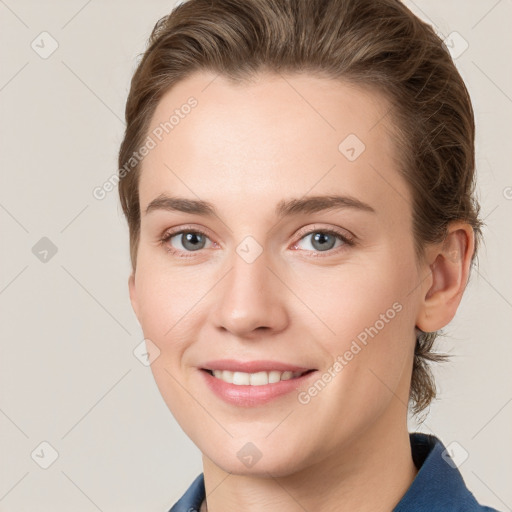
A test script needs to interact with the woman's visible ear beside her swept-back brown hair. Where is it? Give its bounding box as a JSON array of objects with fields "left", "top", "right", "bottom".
[{"left": 416, "top": 221, "right": 475, "bottom": 332}]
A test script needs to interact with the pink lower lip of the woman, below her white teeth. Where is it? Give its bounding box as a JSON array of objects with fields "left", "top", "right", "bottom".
[{"left": 200, "top": 370, "right": 316, "bottom": 407}]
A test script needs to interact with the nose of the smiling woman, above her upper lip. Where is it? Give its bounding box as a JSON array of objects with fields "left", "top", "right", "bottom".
[{"left": 214, "top": 246, "right": 288, "bottom": 338}]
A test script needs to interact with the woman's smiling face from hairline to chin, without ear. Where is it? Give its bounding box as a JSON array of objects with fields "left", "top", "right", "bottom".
[{"left": 130, "top": 73, "right": 422, "bottom": 475}]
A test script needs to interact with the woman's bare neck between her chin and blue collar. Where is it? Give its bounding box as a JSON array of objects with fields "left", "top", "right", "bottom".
[{"left": 201, "top": 401, "right": 417, "bottom": 512}]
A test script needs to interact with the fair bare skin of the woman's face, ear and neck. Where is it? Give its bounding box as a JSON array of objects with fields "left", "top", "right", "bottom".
[{"left": 129, "top": 72, "right": 474, "bottom": 512}]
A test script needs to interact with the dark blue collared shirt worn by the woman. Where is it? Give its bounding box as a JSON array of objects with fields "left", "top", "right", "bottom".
[{"left": 169, "top": 432, "right": 498, "bottom": 512}]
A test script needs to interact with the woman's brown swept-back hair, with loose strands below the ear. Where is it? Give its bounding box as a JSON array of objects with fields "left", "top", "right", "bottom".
[{"left": 118, "top": 0, "right": 482, "bottom": 415}]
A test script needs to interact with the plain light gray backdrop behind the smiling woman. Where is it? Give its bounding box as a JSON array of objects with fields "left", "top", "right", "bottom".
[{"left": 0, "top": 0, "right": 512, "bottom": 512}]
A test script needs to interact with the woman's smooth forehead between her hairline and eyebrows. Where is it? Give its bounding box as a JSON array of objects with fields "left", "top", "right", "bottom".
[{"left": 139, "top": 72, "right": 407, "bottom": 215}]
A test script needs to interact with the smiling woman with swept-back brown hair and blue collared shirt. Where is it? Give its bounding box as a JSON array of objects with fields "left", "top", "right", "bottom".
[{"left": 119, "top": 0, "right": 500, "bottom": 512}]
